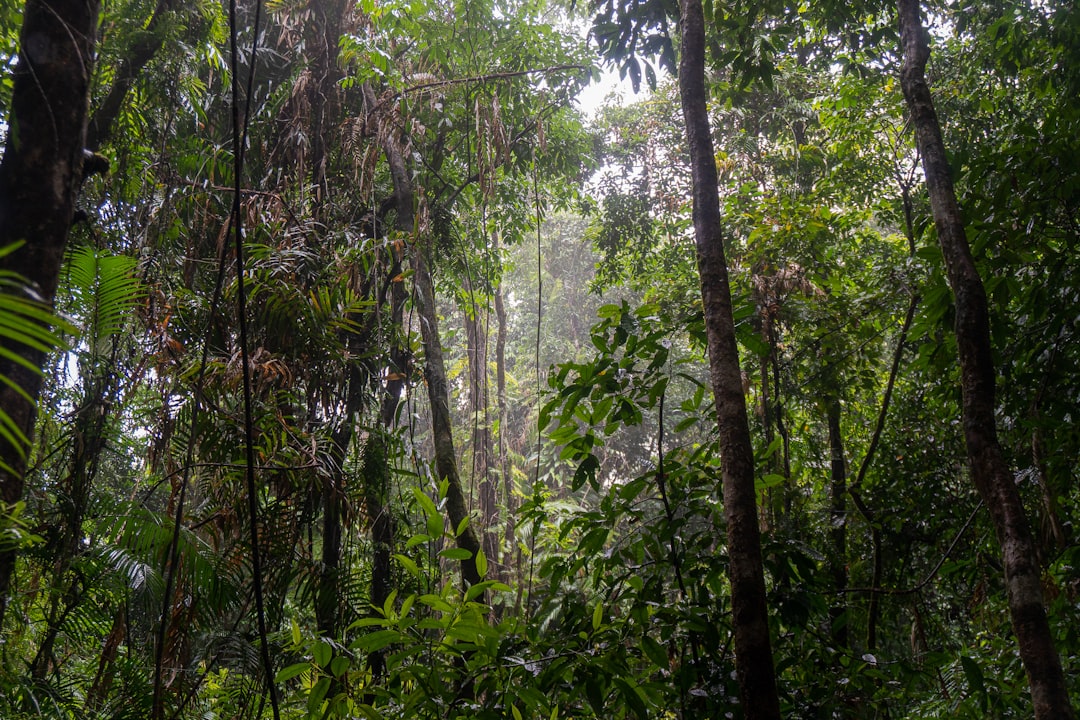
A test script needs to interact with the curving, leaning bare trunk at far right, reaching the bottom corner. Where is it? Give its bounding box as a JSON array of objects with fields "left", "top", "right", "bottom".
[{"left": 897, "top": 0, "right": 1075, "bottom": 720}]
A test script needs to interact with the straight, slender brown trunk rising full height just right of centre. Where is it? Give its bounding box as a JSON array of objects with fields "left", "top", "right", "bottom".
[{"left": 678, "top": 0, "right": 780, "bottom": 720}]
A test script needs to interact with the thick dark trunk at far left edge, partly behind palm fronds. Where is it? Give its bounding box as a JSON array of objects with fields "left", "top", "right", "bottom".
[{"left": 0, "top": 0, "right": 100, "bottom": 627}]
